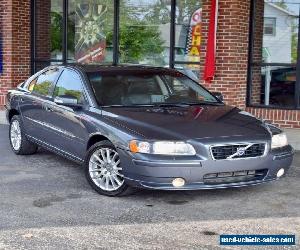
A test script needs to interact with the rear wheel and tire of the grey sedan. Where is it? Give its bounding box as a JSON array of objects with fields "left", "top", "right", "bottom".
[{"left": 9, "top": 115, "right": 38, "bottom": 155}]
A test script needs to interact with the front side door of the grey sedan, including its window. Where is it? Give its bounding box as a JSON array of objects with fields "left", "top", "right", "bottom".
[{"left": 42, "top": 69, "right": 89, "bottom": 159}]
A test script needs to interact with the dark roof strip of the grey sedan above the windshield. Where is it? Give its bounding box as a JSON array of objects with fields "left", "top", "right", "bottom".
[{"left": 63, "top": 64, "right": 179, "bottom": 74}]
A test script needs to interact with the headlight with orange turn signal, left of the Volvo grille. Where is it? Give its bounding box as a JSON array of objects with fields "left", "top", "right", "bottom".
[{"left": 129, "top": 140, "right": 196, "bottom": 155}]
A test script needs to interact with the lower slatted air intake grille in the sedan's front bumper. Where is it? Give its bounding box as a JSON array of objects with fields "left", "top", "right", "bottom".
[{"left": 203, "top": 169, "right": 268, "bottom": 185}]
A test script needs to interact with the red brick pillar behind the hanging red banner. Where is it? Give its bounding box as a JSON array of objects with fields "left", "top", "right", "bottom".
[{"left": 201, "top": 0, "right": 250, "bottom": 108}]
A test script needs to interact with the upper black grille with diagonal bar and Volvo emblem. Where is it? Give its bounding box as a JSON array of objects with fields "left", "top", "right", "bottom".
[{"left": 211, "top": 143, "right": 266, "bottom": 160}]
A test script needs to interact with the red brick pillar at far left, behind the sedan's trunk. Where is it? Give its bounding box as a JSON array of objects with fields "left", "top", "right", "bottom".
[{"left": 0, "top": 0, "right": 30, "bottom": 107}]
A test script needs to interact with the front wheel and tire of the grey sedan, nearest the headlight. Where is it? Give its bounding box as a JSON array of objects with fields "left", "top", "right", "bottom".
[{"left": 85, "top": 140, "right": 134, "bottom": 196}]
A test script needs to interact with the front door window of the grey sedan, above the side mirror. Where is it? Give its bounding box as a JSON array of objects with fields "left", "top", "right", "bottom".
[{"left": 54, "top": 69, "right": 86, "bottom": 104}]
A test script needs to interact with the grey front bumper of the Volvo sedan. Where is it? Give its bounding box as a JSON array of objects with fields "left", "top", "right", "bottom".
[{"left": 119, "top": 146, "right": 294, "bottom": 190}]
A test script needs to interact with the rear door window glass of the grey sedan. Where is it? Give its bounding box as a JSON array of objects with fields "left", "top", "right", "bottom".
[{"left": 32, "top": 68, "right": 59, "bottom": 96}]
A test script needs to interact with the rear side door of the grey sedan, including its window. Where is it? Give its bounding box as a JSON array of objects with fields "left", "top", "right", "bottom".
[{"left": 19, "top": 67, "right": 59, "bottom": 141}]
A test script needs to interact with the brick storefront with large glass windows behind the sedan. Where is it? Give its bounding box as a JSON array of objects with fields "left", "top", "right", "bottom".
[{"left": 0, "top": 0, "right": 300, "bottom": 128}]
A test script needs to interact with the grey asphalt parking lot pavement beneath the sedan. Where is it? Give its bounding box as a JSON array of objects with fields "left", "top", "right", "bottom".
[{"left": 0, "top": 125, "right": 300, "bottom": 249}]
